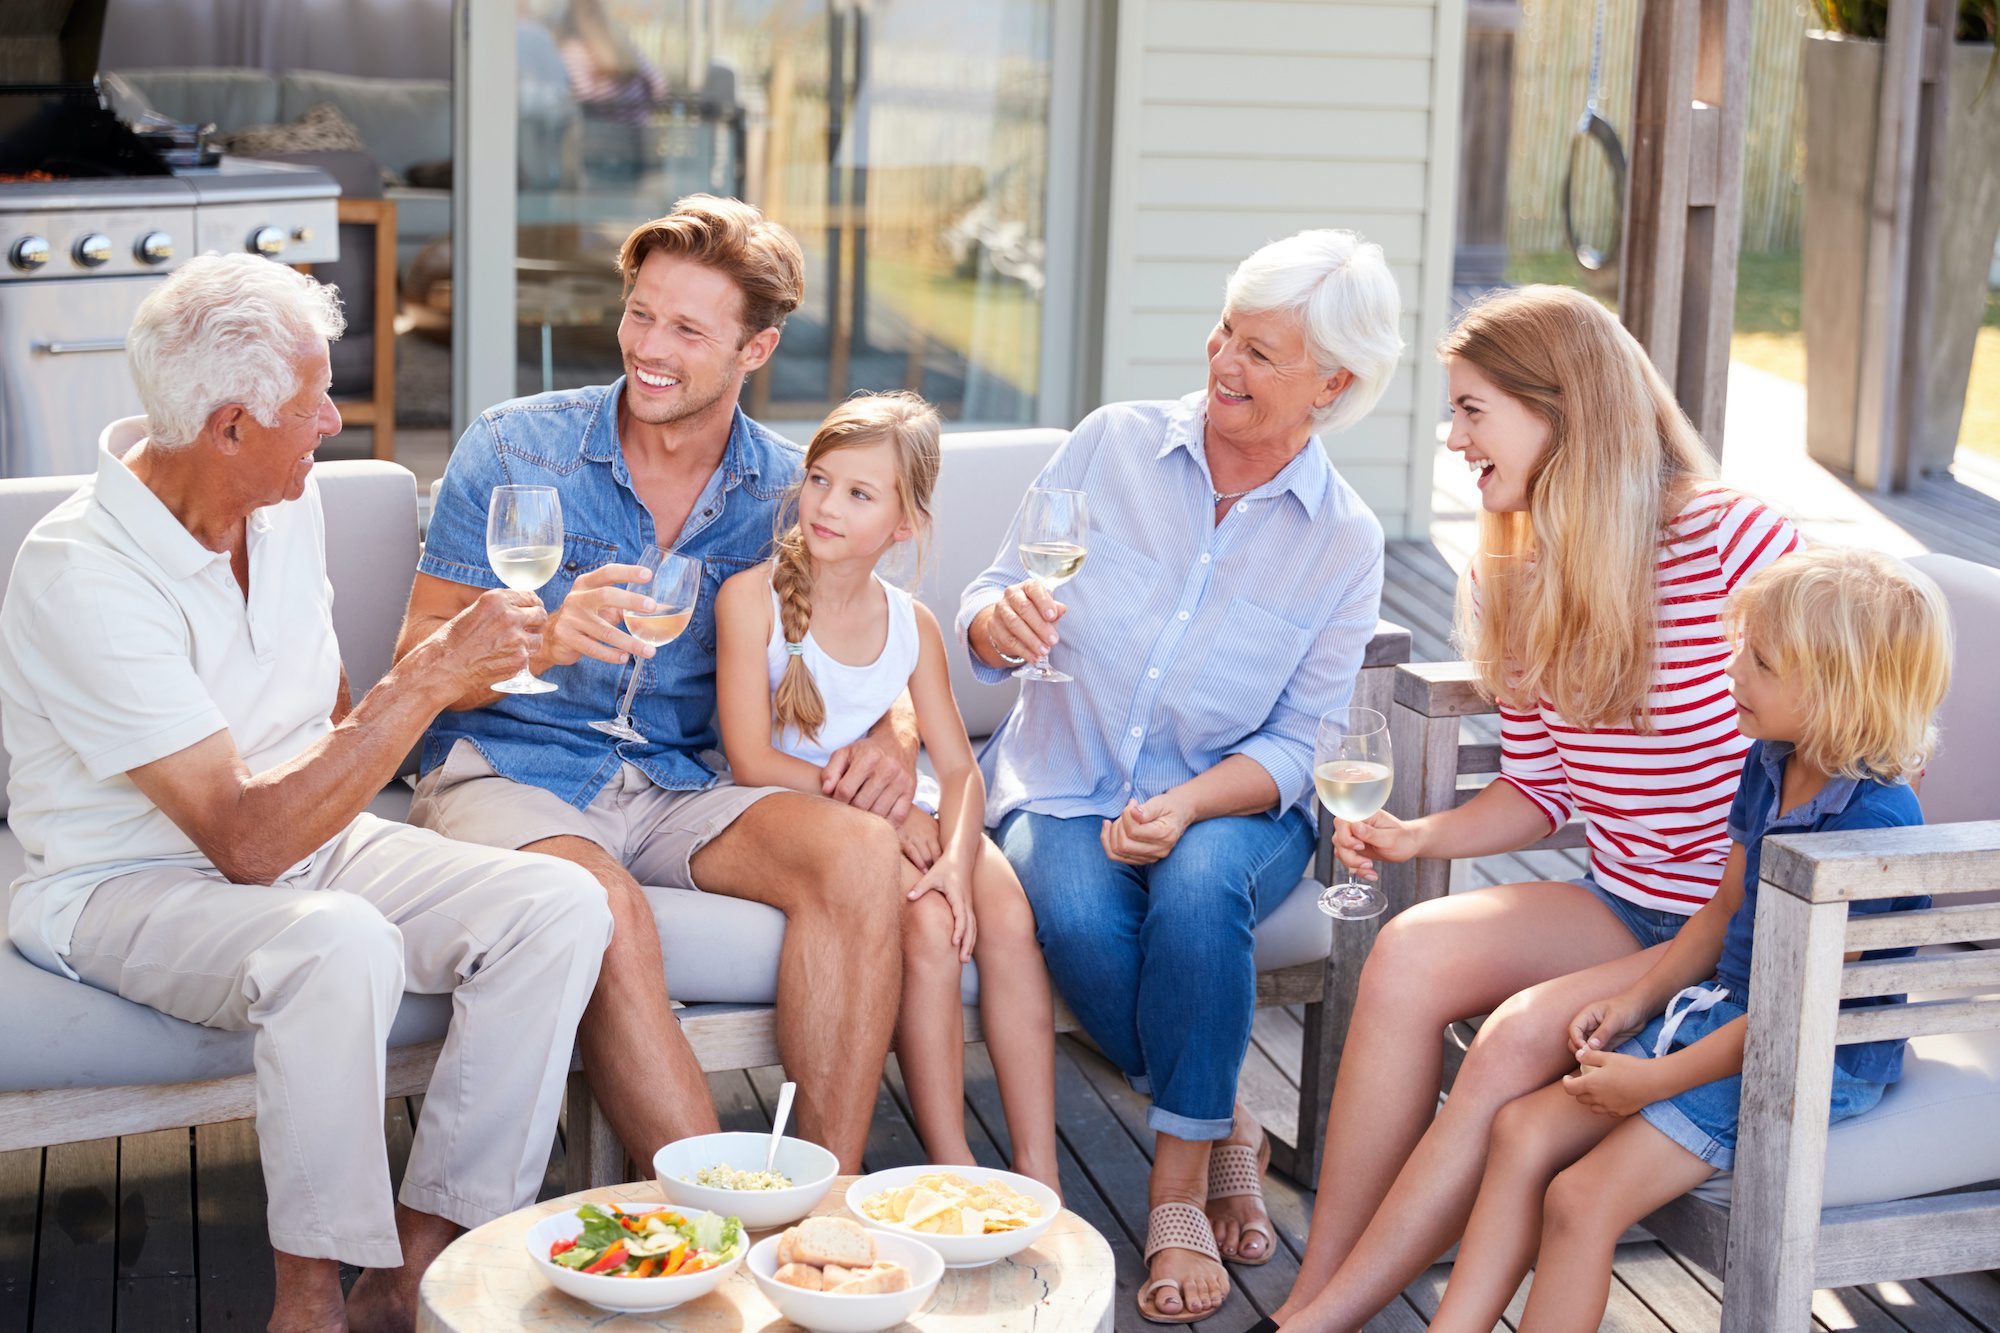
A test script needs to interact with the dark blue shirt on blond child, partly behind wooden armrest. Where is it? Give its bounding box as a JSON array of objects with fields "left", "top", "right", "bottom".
[{"left": 1716, "top": 741, "right": 1930, "bottom": 1083}]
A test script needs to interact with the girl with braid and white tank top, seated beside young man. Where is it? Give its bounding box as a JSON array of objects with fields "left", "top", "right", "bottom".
[{"left": 716, "top": 392, "right": 1058, "bottom": 1189}]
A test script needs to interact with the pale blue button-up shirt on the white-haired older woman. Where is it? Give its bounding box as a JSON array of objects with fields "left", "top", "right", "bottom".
[{"left": 958, "top": 394, "right": 1382, "bottom": 825}]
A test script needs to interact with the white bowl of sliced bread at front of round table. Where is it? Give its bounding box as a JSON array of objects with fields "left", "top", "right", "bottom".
[{"left": 744, "top": 1217, "right": 944, "bottom": 1333}]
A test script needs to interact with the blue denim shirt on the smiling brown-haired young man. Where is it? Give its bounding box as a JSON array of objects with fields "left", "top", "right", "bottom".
[{"left": 418, "top": 378, "right": 804, "bottom": 809}]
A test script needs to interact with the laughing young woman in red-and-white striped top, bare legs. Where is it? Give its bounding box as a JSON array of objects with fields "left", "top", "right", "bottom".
[{"left": 1276, "top": 286, "right": 1798, "bottom": 1333}]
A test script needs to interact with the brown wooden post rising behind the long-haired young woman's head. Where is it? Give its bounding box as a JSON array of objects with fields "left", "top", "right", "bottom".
[{"left": 1618, "top": 0, "right": 1750, "bottom": 458}]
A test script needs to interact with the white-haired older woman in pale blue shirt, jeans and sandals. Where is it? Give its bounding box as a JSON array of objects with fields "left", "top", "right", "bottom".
[{"left": 958, "top": 230, "right": 1402, "bottom": 1323}]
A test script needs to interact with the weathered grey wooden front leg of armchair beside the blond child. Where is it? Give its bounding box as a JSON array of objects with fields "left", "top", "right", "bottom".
[{"left": 1722, "top": 881, "right": 1848, "bottom": 1333}]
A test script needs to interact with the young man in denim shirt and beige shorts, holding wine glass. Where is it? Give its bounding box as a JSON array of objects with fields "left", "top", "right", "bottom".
[{"left": 398, "top": 194, "right": 916, "bottom": 1171}]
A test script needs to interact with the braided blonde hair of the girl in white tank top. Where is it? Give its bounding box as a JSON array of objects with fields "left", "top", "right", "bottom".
[{"left": 770, "top": 388, "right": 942, "bottom": 741}]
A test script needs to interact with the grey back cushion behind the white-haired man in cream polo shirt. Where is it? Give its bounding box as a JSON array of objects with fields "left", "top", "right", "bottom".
[{"left": 0, "top": 460, "right": 416, "bottom": 819}]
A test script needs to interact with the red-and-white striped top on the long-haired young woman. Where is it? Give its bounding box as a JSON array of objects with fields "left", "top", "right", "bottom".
[{"left": 1500, "top": 490, "right": 1804, "bottom": 915}]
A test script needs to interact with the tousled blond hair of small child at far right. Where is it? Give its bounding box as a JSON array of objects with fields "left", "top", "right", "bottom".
[{"left": 1724, "top": 546, "right": 1952, "bottom": 781}]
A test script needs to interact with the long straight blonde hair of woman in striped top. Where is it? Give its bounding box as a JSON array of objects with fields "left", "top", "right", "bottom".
[{"left": 1438, "top": 286, "right": 1716, "bottom": 731}]
